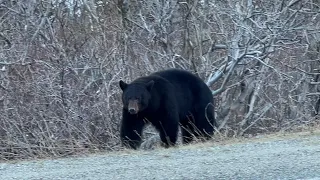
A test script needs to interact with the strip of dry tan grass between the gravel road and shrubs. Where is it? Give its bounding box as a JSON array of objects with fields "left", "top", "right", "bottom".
[{"left": 0, "top": 126, "right": 320, "bottom": 163}]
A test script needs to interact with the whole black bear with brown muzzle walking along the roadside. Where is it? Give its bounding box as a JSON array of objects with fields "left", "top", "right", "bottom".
[{"left": 119, "top": 69, "right": 216, "bottom": 149}]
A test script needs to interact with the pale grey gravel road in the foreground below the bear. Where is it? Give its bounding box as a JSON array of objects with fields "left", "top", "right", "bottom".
[{"left": 0, "top": 131, "right": 320, "bottom": 180}]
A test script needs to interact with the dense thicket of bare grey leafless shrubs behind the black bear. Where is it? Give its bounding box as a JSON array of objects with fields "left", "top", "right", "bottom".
[{"left": 0, "top": 0, "right": 320, "bottom": 160}]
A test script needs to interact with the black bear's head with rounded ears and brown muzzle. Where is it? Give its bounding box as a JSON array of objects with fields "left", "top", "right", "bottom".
[{"left": 119, "top": 80, "right": 154, "bottom": 114}]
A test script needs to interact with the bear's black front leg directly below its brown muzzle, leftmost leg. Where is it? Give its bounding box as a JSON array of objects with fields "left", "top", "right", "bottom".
[{"left": 120, "top": 110, "right": 145, "bottom": 149}]
